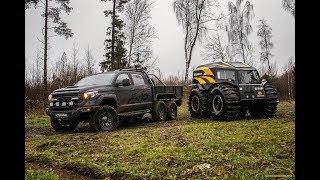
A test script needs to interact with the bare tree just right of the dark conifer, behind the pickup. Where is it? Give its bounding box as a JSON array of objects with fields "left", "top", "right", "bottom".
[{"left": 124, "top": 0, "right": 156, "bottom": 66}]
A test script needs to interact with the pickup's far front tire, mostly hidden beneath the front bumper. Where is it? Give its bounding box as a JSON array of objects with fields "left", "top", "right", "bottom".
[{"left": 50, "top": 117, "right": 79, "bottom": 132}]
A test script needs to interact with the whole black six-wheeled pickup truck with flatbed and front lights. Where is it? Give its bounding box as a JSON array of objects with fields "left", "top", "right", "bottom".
[{"left": 46, "top": 68, "right": 183, "bottom": 131}]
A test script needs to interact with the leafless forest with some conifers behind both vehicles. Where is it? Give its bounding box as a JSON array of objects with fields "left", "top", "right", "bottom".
[{"left": 25, "top": 0, "right": 295, "bottom": 115}]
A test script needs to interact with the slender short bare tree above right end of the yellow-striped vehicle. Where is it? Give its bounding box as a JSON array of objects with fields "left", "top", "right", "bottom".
[{"left": 257, "top": 19, "right": 273, "bottom": 74}]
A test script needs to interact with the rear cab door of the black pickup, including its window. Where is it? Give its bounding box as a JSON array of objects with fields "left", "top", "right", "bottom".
[{"left": 131, "top": 73, "right": 152, "bottom": 111}]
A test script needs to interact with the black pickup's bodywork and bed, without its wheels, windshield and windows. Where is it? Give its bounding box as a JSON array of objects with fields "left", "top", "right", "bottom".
[{"left": 46, "top": 69, "right": 182, "bottom": 131}]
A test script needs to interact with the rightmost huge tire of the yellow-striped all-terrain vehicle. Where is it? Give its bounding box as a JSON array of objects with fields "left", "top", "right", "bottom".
[{"left": 250, "top": 84, "right": 279, "bottom": 119}]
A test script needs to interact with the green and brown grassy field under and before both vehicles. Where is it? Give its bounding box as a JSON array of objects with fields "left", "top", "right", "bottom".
[{"left": 25, "top": 102, "right": 295, "bottom": 179}]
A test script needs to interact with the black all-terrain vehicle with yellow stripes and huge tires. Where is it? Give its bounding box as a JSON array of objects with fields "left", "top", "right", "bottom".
[{"left": 188, "top": 62, "right": 279, "bottom": 120}]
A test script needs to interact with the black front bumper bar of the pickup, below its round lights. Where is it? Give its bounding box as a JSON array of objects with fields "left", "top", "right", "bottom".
[{"left": 46, "top": 106, "right": 100, "bottom": 118}]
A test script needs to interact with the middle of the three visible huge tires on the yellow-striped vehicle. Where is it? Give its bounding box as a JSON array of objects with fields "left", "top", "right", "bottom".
[{"left": 210, "top": 84, "right": 241, "bottom": 120}]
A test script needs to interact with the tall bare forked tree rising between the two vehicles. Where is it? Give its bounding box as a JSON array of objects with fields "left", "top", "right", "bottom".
[{"left": 173, "top": 0, "right": 221, "bottom": 83}]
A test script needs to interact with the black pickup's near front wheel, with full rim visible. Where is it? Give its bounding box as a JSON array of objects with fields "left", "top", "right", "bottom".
[{"left": 89, "top": 105, "right": 119, "bottom": 132}]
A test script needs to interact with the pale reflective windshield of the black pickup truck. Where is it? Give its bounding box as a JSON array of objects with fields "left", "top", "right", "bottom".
[{"left": 75, "top": 73, "right": 115, "bottom": 86}]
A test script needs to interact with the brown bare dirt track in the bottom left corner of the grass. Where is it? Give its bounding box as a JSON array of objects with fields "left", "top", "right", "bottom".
[{"left": 25, "top": 163, "right": 93, "bottom": 180}]
